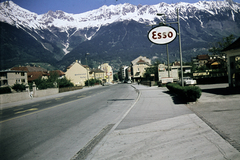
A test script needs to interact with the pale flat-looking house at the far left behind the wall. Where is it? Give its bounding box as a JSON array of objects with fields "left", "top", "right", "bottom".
[{"left": 0, "top": 70, "right": 28, "bottom": 87}]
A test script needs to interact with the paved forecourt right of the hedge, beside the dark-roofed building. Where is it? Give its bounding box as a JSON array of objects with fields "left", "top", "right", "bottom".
[{"left": 187, "top": 83, "right": 240, "bottom": 151}]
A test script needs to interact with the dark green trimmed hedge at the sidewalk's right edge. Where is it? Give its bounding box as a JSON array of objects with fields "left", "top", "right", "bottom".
[{"left": 167, "top": 83, "right": 202, "bottom": 102}]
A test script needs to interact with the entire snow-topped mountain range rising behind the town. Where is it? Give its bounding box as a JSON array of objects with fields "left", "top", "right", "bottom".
[{"left": 0, "top": 0, "right": 240, "bottom": 71}]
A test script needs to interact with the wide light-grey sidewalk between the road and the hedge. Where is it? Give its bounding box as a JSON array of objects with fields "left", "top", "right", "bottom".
[{"left": 87, "top": 84, "right": 240, "bottom": 160}]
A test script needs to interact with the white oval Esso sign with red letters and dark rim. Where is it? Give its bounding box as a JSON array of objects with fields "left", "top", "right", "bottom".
[{"left": 148, "top": 26, "right": 177, "bottom": 44}]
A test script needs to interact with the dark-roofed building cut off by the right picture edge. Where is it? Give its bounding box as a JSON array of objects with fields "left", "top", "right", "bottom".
[{"left": 222, "top": 37, "right": 240, "bottom": 87}]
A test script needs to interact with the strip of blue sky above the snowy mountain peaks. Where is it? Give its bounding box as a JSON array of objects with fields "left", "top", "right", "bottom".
[{"left": 0, "top": 0, "right": 240, "bottom": 14}]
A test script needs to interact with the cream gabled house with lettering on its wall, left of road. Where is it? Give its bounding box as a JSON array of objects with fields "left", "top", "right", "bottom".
[{"left": 65, "top": 60, "right": 90, "bottom": 86}]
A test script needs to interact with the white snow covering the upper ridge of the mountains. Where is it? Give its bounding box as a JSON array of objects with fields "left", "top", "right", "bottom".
[{"left": 0, "top": 0, "right": 240, "bottom": 54}]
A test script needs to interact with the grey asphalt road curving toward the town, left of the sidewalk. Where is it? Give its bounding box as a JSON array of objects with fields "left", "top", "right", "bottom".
[{"left": 0, "top": 84, "right": 137, "bottom": 160}]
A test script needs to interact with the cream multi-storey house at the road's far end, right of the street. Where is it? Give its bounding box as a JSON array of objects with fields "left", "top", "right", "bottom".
[{"left": 130, "top": 56, "right": 151, "bottom": 81}]
